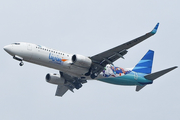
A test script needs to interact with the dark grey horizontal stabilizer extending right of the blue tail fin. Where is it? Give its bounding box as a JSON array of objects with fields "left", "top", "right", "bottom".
[{"left": 144, "top": 66, "right": 177, "bottom": 80}]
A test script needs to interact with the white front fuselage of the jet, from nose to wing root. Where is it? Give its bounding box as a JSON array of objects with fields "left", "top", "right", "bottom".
[{"left": 4, "top": 42, "right": 95, "bottom": 77}]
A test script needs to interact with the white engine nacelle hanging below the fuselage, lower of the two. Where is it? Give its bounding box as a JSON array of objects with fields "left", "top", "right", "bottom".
[{"left": 46, "top": 73, "right": 65, "bottom": 85}]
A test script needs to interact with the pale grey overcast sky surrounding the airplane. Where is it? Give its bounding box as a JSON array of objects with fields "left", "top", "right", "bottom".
[{"left": 0, "top": 0, "right": 180, "bottom": 120}]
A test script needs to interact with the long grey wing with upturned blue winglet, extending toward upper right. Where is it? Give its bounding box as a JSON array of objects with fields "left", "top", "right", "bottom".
[{"left": 90, "top": 23, "right": 159, "bottom": 76}]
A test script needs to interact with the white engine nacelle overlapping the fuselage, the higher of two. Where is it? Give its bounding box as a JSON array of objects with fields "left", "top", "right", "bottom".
[{"left": 72, "top": 54, "right": 92, "bottom": 68}]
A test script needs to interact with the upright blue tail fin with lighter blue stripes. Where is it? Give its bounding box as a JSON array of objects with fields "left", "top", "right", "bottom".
[{"left": 132, "top": 50, "right": 154, "bottom": 74}]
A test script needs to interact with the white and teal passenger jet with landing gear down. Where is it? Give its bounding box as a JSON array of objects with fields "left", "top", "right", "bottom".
[{"left": 4, "top": 23, "right": 177, "bottom": 97}]
